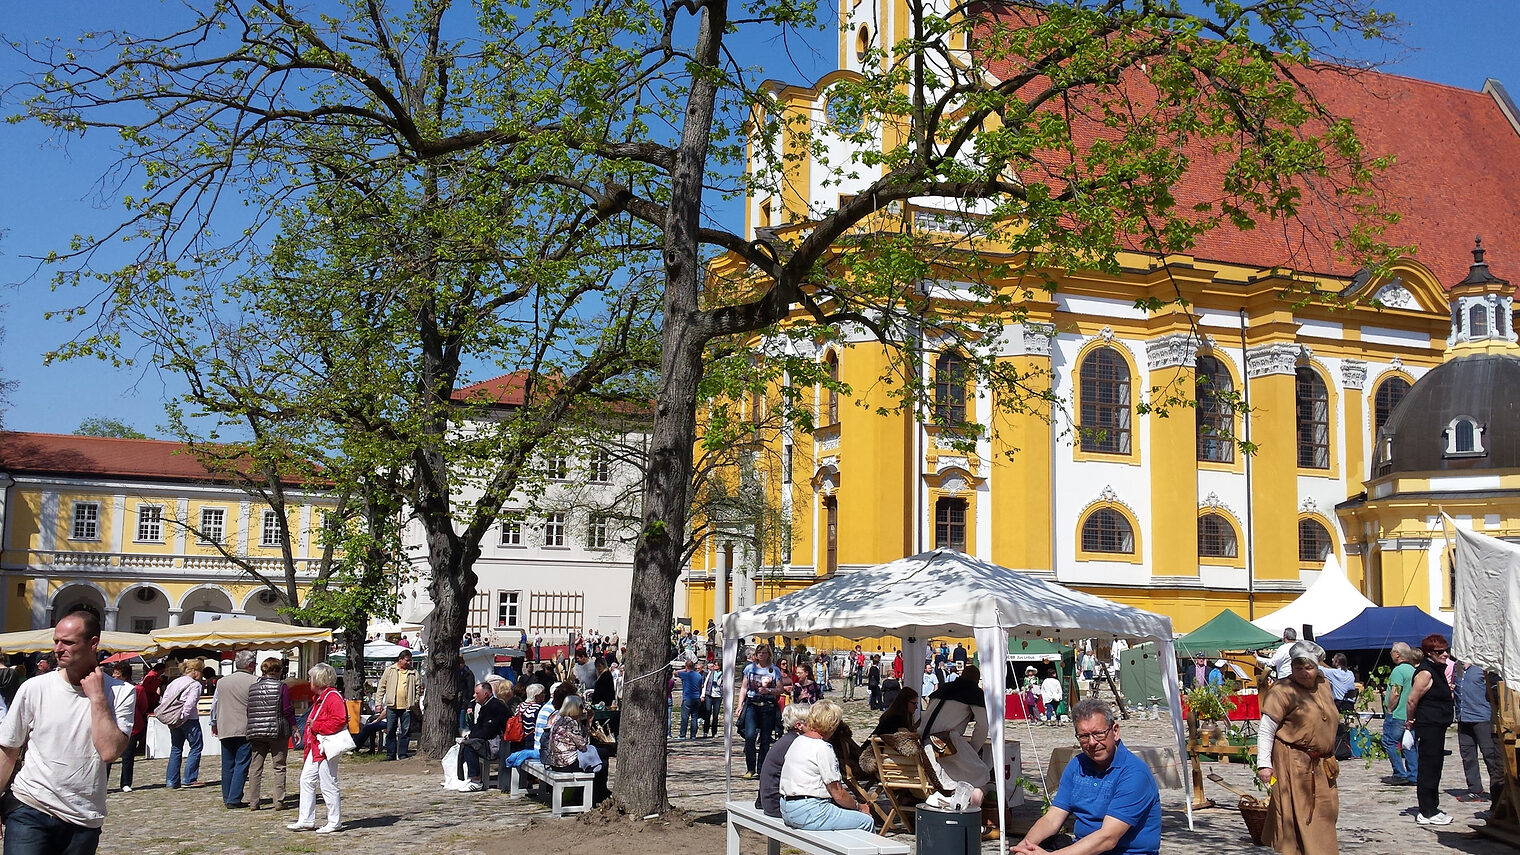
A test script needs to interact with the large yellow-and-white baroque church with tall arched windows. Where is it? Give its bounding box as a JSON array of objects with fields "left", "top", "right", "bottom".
[{"left": 684, "top": 8, "right": 1520, "bottom": 631}]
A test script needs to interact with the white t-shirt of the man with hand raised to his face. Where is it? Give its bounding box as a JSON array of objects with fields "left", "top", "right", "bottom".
[{"left": 0, "top": 671, "right": 137, "bottom": 828}]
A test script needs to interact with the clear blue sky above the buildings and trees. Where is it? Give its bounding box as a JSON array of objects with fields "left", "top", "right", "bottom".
[{"left": 0, "top": 0, "right": 1520, "bottom": 435}]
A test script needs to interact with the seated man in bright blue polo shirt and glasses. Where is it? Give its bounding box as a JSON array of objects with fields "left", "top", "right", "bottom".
[{"left": 1012, "top": 698, "right": 1161, "bottom": 855}]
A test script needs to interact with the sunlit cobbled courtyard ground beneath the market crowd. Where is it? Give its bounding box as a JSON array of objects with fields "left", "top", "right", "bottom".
[{"left": 100, "top": 701, "right": 1512, "bottom": 855}]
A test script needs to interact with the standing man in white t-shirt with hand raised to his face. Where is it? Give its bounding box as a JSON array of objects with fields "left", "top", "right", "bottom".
[{"left": 0, "top": 612, "right": 137, "bottom": 855}]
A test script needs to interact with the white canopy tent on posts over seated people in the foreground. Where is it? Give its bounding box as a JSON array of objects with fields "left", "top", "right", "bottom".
[{"left": 724, "top": 549, "right": 1193, "bottom": 852}]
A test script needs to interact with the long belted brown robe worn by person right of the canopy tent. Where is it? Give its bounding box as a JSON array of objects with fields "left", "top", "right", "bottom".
[{"left": 1262, "top": 675, "right": 1341, "bottom": 855}]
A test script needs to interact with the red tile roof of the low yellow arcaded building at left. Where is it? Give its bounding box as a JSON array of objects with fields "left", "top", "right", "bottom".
[{"left": 0, "top": 431, "right": 226, "bottom": 481}]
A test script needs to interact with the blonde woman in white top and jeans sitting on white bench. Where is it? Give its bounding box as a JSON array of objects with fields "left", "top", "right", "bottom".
[{"left": 781, "top": 700, "right": 876, "bottom": 831}]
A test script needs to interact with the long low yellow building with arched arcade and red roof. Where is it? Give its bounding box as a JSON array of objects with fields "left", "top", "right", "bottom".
[{"left": 0, "top": 432, "right": 331, "bottom": 633}]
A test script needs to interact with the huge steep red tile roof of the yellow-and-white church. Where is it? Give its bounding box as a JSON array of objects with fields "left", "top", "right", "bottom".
[{"left": 993, "top": 24, "right": 1520, "bottom": 288}]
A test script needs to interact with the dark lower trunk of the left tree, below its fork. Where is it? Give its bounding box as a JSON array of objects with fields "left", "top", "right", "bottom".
[{"left": 421, "top": 535, "right": 476, "bottom": 758}]
